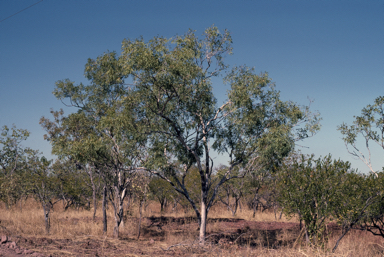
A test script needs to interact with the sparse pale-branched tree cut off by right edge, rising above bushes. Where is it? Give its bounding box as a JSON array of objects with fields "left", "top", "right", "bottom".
[{"left": 338, "top": 96, "right": 384, "bottom": 177}]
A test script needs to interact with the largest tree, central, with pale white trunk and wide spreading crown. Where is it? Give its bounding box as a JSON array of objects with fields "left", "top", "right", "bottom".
[{"left": 119, "top": 27, "right": 319, "bottom": 245}]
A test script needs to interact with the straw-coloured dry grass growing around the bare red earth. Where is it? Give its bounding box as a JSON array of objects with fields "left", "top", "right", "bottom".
[{"left": 0, "top": 199, "right": 384, "bottom": 257}]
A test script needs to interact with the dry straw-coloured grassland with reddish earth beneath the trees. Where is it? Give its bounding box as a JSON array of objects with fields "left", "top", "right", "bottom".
[{"left": 0, "top": 199, "right": 384, "bottom": 257}]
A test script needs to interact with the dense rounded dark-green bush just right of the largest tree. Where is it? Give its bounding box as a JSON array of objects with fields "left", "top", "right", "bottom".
[{"left": 276, "top": 155, "right": 352, "bottom": 244}]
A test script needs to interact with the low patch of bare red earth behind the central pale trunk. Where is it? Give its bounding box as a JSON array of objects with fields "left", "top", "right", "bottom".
[{"left": 143, "top": 217, "right": 300, "bottom": 248}]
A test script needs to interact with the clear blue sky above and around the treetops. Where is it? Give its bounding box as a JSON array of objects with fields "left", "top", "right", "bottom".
[{"left": 0, "top": 0, "right": 384, "bottom": 171}]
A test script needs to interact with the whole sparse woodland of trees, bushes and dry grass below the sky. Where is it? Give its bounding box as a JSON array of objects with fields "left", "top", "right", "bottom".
[{"left": 0, "top": 27, "right": 384, "bottom": 256}]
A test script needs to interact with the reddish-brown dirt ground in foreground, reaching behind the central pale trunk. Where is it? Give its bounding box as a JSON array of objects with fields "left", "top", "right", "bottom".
[{"left": 0, "top": 217, "right": 344, "bottom": 257}]
